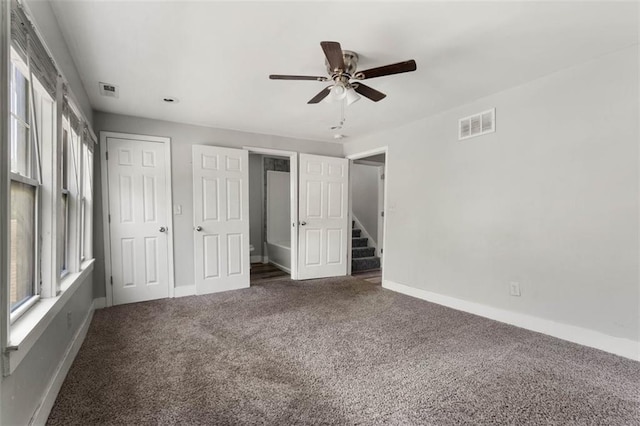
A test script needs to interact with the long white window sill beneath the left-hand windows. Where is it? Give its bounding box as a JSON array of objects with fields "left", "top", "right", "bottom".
[{"left": 3, "top": 259, "right": 94, "bottom": 376}]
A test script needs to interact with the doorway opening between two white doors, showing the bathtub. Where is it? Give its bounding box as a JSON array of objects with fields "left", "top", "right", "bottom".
[{"left": 245, "top": 148, "right": 298, "bottom": 284}]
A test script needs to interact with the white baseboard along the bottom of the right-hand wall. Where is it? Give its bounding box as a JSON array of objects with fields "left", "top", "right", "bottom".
[{"left": 382, "top": 280, "right": 640, "bottom": 361}]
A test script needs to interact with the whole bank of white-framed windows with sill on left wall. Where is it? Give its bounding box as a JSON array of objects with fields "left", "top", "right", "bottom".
[{"left": 0, "top": 1, "right": 95, "bottom": 374}]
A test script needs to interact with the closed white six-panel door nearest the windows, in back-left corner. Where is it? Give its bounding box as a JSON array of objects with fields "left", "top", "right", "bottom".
[{"left": 106, "top": 137, "right": 171, "bottom": 305}]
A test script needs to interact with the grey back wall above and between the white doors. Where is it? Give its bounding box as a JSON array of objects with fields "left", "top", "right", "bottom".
[{"left": 94, "top": 112, "right": 342, "bottom": 297}]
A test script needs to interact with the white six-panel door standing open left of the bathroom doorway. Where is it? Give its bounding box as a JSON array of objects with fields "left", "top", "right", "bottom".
[{"left": 193, "top": 145, "right": 250, "bottom": 294}]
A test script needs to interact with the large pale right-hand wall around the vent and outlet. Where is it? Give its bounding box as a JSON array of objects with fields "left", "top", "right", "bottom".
[{"left": 344, "top": 45, "right": 640, "bottom": 350}]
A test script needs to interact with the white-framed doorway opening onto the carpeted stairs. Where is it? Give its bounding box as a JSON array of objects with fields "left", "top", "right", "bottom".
[{"left": 349, "top": 148, "right": 387, "bottom": 284}]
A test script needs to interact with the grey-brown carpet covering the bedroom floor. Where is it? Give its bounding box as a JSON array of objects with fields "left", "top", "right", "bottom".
[{"left": 49, "top": 277, "right": 640, "bottom": 425}]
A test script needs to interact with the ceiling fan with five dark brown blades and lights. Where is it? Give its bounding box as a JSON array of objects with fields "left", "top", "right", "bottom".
[{"left": 269, "top": 41, "right": 416, "bottom": 105}]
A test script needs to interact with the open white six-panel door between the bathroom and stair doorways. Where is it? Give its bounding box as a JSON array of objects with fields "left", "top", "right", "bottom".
[{"left": 298, "top": 154, "right": 349, "bottom": 279}]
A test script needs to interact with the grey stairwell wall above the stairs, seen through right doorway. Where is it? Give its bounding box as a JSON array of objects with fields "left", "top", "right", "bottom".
[{"left": 350, "top": 163, "right": 380, "bottom": 243}]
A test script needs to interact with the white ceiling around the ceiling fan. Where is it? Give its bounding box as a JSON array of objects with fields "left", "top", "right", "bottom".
[{"left": 48, "top": 0, "right": 638, "bottom": 145}]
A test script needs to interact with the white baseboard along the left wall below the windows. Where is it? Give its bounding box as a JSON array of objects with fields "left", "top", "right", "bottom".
[{"left": 29, "top": 297, "right": 99, "bottom": 425}]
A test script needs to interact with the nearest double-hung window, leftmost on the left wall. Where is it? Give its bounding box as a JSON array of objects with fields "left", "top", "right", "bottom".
[{"left": 9, "top": 51, "right": 40, "bottom": 319}]
